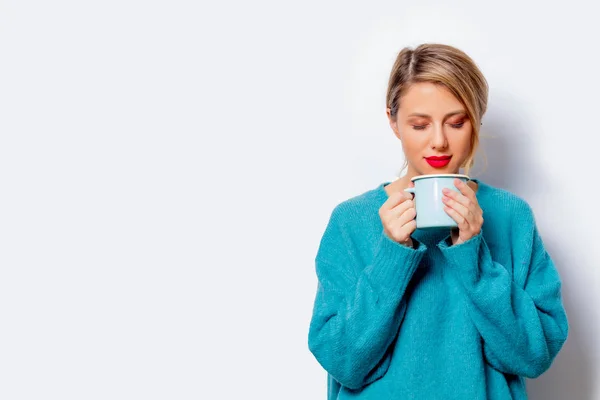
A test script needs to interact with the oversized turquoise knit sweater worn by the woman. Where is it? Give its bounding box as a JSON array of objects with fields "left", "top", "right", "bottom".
[{"left": 308, "top": 180, "right": 568, "bottom": 400}]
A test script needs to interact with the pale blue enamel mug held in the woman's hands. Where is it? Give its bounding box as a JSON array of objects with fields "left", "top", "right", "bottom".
[{"left": 404, "top": 174, "right": 470, "bottom": 229}]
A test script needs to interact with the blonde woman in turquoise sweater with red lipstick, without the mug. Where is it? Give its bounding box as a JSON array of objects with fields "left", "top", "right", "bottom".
[{"left": 308, "top": 44, "right": 568, "bottom": 400}]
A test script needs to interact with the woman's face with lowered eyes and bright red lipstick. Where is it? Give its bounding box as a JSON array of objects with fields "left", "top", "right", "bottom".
[{"left": 387, "top": 82, "right": 473, "bottom": 177}]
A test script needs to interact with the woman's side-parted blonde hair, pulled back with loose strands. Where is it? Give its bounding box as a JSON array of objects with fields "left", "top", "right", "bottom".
[{"left": 386, "top": 43, "right": 489, "bottom": 175}]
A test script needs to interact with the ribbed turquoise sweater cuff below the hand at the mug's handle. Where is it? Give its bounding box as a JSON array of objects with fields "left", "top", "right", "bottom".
[{"left": 369, "top": 232, "right": 427, "bottom": 293}]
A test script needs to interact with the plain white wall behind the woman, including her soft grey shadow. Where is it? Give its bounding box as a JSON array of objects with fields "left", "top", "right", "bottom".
[{"left": 0, "top": 0, "right": 600, "bottom": 400}]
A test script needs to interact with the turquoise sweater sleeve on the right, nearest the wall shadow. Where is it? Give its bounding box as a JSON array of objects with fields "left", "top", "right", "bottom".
[{"left": 438, "top": 222, "right": 569, "bottom": 378}]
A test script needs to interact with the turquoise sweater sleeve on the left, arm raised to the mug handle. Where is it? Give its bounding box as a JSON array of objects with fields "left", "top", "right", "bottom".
[{"left": 308, "top": 208, "right": 426, "bottom": 390}]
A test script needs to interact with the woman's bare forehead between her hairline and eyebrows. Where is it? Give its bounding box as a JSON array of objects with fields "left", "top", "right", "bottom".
[{"left": 398, "top": 82, "right": 465, "bottom": 117}]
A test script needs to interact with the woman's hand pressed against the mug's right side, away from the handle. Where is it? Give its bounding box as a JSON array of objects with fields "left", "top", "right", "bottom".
[{"left": 442, "top": 179, "right": 483, "bottom": 245}]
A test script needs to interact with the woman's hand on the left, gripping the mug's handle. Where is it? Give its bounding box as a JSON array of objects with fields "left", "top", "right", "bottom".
[{"left": 379, "top": 182, "right": 417, "bottom": 248}]
